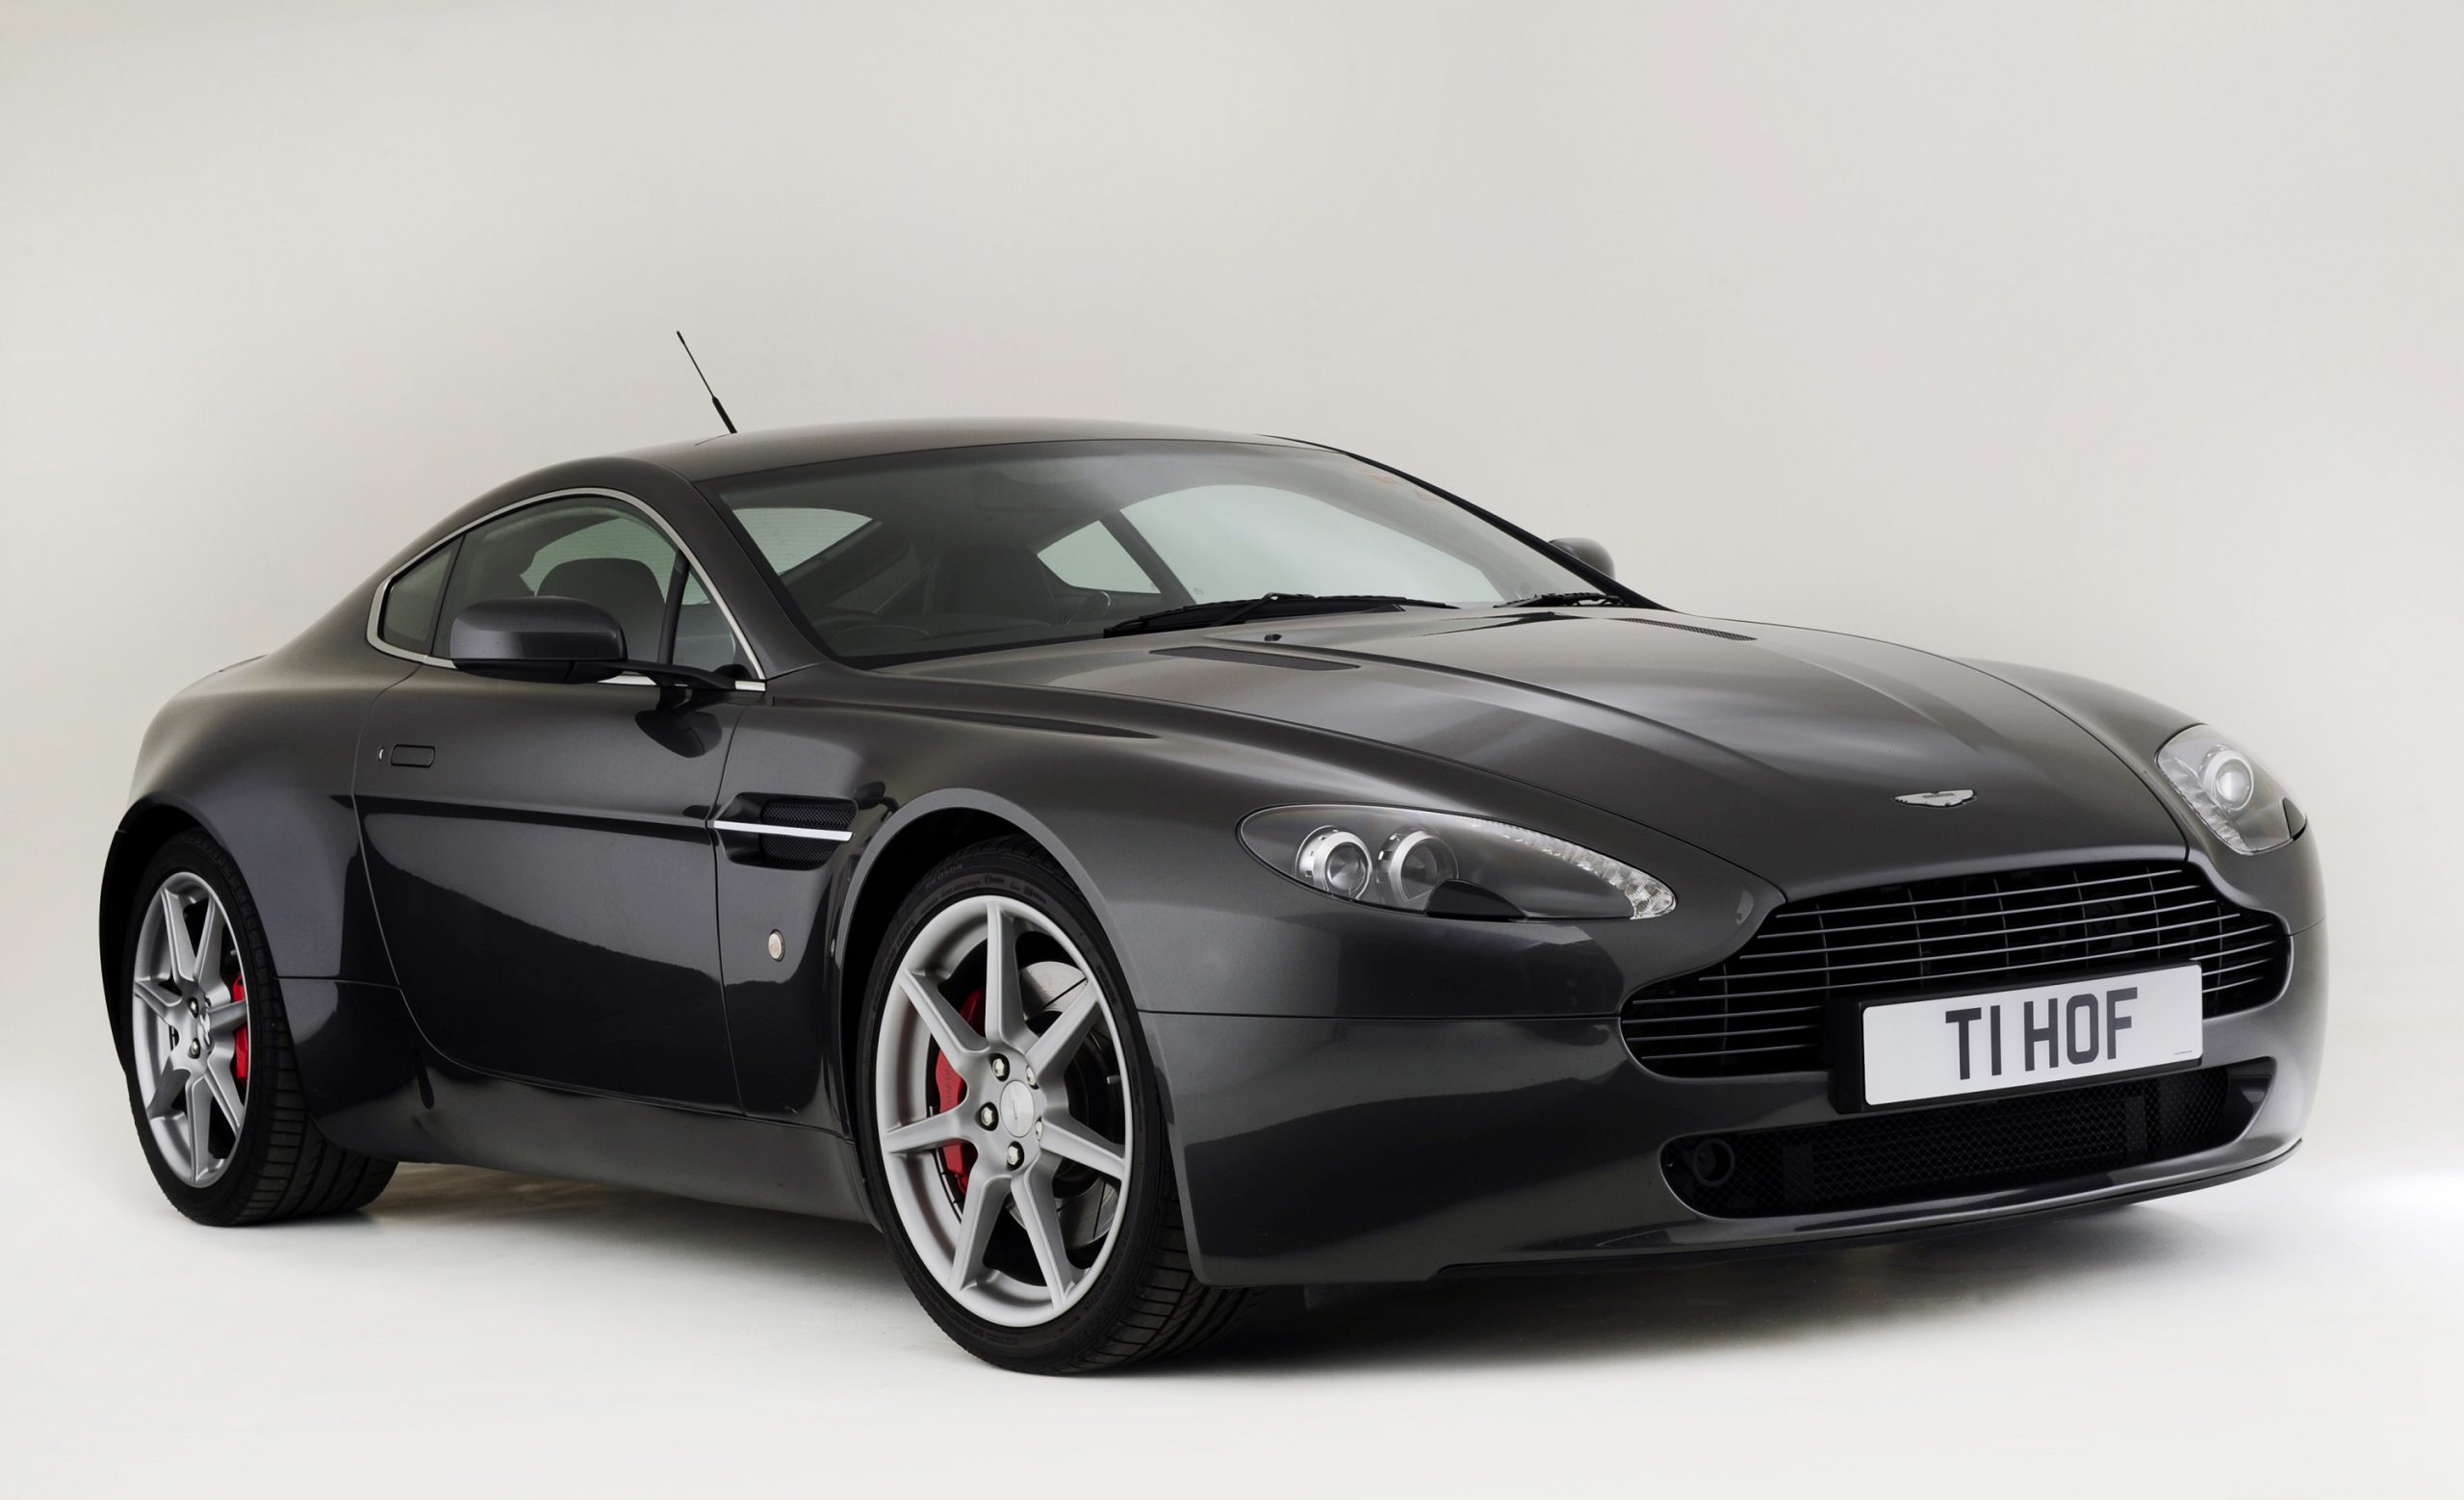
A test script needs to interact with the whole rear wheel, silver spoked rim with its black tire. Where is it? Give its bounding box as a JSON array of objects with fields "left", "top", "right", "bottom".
[{"left": 114, "top": 830, "right": 395, "bottom": 1224}]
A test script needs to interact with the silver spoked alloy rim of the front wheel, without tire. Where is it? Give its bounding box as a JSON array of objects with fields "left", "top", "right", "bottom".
[{"left": 872, "top": 896, "right": 1134, "bottom": 1328}]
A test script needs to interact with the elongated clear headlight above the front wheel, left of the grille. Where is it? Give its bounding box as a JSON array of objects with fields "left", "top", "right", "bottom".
[{"left": 1240, "top": 808, "right": 1678, "bottom": 921}]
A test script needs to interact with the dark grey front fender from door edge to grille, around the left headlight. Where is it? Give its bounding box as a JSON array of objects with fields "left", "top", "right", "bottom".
[{"left": 720, "top": 680, "right": 1779, "bottom": 1128}]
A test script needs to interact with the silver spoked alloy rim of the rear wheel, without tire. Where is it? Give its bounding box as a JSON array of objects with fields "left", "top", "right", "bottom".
[{"left": 128, "top": 869, "right": 249, "bottom": 1187}]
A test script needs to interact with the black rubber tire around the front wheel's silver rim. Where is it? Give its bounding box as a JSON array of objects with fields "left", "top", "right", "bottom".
[{"left": 848, "top": 838, "right": 1246, "bottom": 1375}]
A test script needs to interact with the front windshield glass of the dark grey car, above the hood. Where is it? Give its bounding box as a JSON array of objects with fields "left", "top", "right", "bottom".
[{"left": 709, "top": 441, "right": 1592, "bottom": 665}]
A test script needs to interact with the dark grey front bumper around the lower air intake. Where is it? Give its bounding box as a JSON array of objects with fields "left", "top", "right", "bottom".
[{"left": 1141, "top": 923, "right": 2326, "bottom": 1285}]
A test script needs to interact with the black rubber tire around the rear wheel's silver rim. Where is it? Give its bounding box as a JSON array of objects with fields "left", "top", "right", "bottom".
[{"left": 109, "top": 830, "right": 395, "bottom": 1227}]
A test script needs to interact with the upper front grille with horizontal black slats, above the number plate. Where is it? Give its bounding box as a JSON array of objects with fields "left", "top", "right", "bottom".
[{"left": 1621, "top": 865, "right": 2292, "bottom": 1079}]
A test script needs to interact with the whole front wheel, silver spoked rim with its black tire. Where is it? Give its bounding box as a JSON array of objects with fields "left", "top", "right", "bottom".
[{"left": 860, "top": 840, "right": 1242, "bottom": 1375}]
